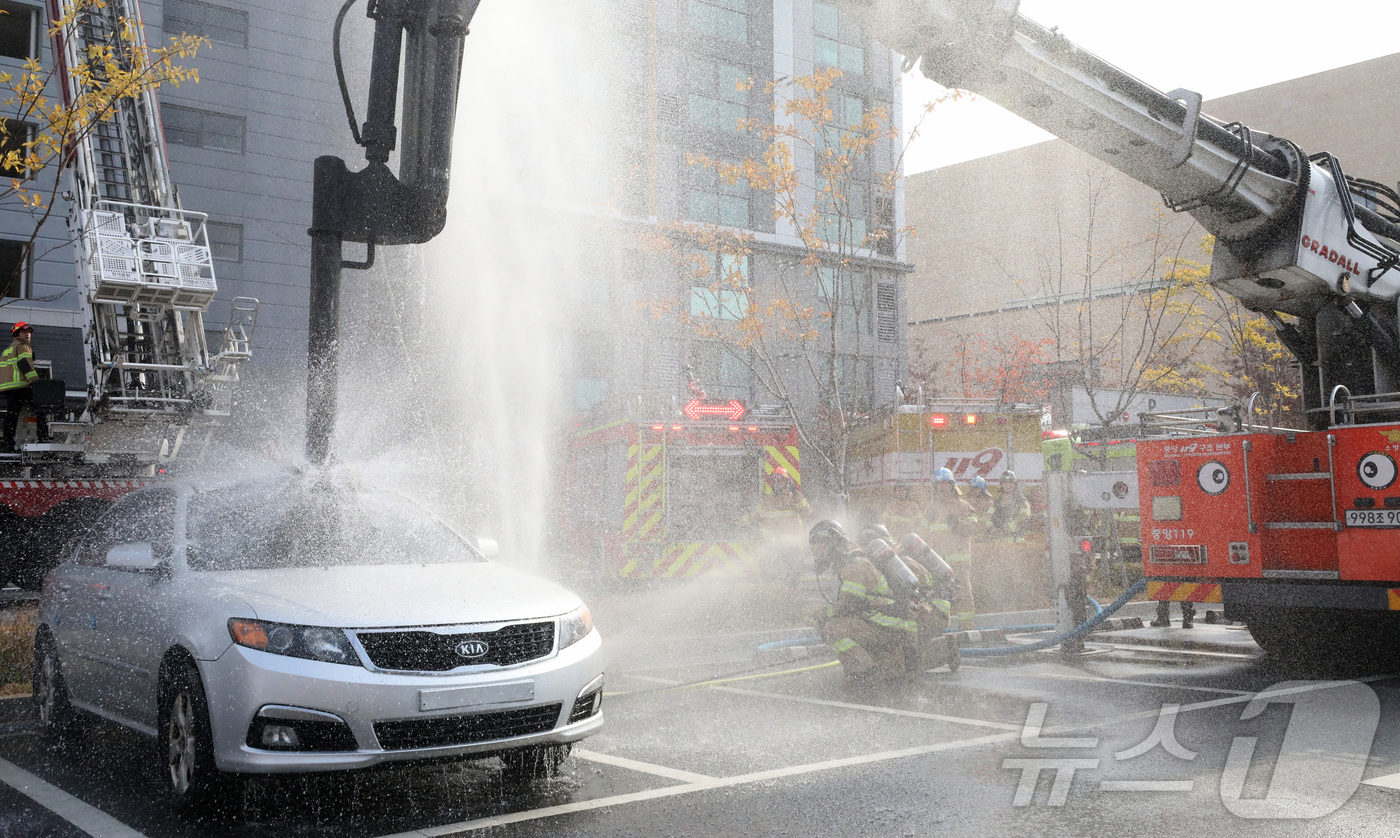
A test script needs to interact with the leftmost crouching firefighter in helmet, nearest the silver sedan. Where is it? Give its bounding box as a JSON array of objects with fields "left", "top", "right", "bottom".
[{"left": 808, "top": 519, "right": 918, "bottom": 690}]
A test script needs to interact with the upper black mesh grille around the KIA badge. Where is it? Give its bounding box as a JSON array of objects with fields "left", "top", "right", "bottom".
[{"left": 356, "top": 620, "right": 554, "bottom": 672}]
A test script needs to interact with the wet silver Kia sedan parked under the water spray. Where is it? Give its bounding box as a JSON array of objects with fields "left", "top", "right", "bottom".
[{"left": 34, "top": 477, "right": 602, "bottom": 807}]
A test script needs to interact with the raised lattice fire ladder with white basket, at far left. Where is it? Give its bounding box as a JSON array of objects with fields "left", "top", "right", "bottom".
[{"left": 50, "top": 0, "right": 258, "bottom": 460}]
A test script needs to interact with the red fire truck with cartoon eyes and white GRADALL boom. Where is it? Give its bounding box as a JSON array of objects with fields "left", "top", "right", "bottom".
[{"left": 837, "top": 0, "right": 1400, "bottom": 653}]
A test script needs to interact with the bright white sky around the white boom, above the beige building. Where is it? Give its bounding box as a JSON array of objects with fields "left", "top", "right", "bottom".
[{"left": 903, "top": 0, "right": 1400, "bottom": 175}]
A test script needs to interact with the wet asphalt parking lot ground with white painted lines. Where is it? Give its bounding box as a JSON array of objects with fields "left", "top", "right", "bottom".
[{"left": 0, "top": 584, "right": 1400, "bottom": 838}]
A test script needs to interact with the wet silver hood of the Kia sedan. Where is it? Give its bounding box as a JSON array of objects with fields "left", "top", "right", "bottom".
[{"left": 199, "top": 562, "right": 580, "bottom": 628}]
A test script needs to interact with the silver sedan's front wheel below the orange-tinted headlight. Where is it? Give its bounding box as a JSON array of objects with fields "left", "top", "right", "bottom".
[{"left": 157, "top": 660, "right": 232, "bottom": 814}]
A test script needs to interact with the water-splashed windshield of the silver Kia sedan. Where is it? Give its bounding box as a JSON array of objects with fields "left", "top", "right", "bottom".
[{"left": 186, "top": 480, "right": 484, "bottom": 571}]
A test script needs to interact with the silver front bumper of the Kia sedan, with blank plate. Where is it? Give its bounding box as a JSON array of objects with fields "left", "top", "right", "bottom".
[{"left": 200, "top": 631, "right": 603, "bottom": 774}]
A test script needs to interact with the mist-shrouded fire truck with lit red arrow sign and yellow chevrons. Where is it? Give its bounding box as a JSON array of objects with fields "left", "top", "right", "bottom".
[{"left": 564, "top": 400, "right": 802, "bottom": 579}]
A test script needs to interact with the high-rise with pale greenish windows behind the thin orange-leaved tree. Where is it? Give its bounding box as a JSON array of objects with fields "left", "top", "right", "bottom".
[{"left": 573, "top": 0, "right": 910, "bottom": 444}]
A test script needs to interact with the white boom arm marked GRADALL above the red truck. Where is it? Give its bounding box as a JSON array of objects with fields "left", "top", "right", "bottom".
[{"left": 837, "top": 0, "right": 1400, "bottom": 424}]
